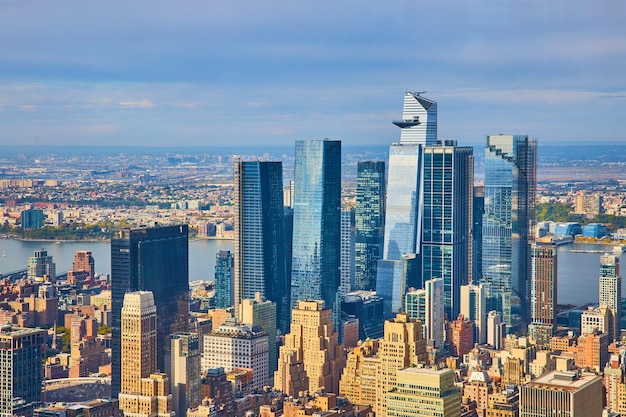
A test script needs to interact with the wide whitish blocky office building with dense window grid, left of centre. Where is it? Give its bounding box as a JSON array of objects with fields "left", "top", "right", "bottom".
[{"left": 201, "top": 317, "right": 269, "bottom": 388}]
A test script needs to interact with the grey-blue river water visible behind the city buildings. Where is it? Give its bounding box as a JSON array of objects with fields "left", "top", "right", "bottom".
[{"left": 0, "top": 239, "right": 626, "bottom": 305}]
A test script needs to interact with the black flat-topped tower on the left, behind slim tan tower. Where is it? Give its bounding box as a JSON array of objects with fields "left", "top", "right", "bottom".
[{"left": 111, "top": 225, "right": 189, "bottom": 397}]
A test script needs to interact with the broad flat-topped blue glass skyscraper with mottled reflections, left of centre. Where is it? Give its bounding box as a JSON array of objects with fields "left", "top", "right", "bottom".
[{"left": 291, "top": 139, "right": 341, "bottom": 314}]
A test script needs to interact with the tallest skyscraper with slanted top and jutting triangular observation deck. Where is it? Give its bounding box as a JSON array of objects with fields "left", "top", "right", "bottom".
[{"left": 376, "top": 91, "right": 437, "bottom": 317}]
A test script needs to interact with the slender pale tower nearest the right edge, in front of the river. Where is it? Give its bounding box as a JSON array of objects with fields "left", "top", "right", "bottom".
[{"left": 600, "top": 254, "right": 622, "bottom": 340}]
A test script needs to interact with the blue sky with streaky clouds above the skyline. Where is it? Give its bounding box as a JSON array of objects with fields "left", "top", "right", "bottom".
[{"left": 0, "top": 0, "right": 626, "bottom": 147}]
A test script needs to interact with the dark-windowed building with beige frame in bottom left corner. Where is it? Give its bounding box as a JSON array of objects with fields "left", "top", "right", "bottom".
[{"left": 0, "top": 324, "right": 46, "bottom": 416}]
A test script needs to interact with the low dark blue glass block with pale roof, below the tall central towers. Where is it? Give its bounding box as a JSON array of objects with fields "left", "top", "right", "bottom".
[{"left": 341, "top": 291, "right": 384, "bottom": 340}]
